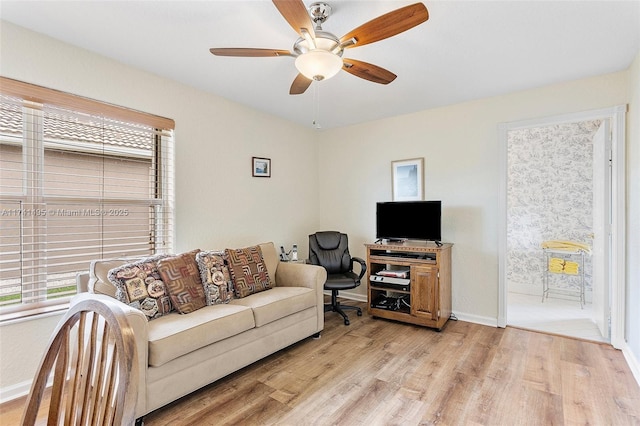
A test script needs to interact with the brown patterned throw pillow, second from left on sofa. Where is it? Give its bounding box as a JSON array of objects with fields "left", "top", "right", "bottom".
[{"left": 158, "top": 250, "right": 207, "bottom": 314}]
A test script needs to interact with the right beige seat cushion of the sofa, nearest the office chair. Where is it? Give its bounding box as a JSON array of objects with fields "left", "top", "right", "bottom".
[{"left": 229, "top": 287, "right": 317, "bottom": 327}]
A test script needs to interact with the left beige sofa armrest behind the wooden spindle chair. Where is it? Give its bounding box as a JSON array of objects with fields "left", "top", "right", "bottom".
[{"left": 70, "top": 293, "right": 149, "bottom": 417}]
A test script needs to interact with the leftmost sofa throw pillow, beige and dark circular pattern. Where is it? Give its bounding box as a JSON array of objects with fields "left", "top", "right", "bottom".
[{"left": 107, "top": 254, "right": 172, "bottom": 321}]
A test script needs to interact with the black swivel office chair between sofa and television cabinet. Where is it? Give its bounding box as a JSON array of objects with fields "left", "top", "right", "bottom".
[{"left": 309, "top": 231, "right": 367, "bottom": 325}]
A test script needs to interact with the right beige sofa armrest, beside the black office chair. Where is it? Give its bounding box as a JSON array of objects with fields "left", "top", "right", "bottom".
[{"left": 276, "top": 262, "right": 327, "bottom": 332}]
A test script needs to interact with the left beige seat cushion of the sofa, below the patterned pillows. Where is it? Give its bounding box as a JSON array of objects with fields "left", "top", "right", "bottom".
[{"left": 149, "top": 304, "right": 255, "bottom": 367}]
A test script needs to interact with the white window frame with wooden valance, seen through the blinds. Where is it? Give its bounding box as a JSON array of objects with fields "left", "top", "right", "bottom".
[{"left": 0, "top": 77, "right": 174, "bottom": 322}]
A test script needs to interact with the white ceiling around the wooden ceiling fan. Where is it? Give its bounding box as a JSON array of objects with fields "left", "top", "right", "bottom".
[{"left": 0, "top": 0, "right": 640, "bottom": 128}]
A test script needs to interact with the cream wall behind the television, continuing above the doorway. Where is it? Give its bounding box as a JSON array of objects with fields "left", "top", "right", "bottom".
[{"left": 319, "top": 72, "right": 628, "bottom": 325}]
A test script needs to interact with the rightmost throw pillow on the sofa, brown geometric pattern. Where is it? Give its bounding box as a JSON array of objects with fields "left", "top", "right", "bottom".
[{"left": 225, "top": 246, "right": 271, "bottom": 297}]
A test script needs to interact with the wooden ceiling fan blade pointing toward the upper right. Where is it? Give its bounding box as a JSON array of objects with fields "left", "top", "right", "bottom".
[{"left": 340, "top": 3, "right": 429, "bottom": 48}]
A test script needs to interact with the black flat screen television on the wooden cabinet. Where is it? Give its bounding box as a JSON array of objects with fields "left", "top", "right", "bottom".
[{"left": 376, "top": 201, "right": 442, "bottom": 243}]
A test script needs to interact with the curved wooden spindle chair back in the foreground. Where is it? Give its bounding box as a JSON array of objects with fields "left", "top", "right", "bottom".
[{"left": 22, "top": 299, "right": 138, "bottom": 426}]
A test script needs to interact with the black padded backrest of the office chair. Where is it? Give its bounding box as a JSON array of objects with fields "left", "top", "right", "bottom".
[{"left": 309, "top": 231, "right": 351, "bottom": 274}]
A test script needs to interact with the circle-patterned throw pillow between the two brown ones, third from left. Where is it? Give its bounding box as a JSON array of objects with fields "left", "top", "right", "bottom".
[{"left": 196, "top": 251, "right": 233, "bottom": 305}]
